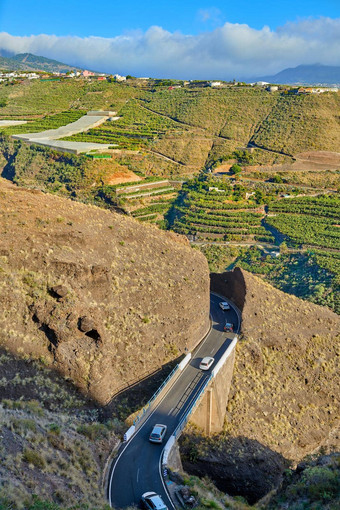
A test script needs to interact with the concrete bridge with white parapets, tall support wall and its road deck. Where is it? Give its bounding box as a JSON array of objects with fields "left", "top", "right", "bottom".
[{"left": 108, "top": 294, "right": 240, "bottom": 508}]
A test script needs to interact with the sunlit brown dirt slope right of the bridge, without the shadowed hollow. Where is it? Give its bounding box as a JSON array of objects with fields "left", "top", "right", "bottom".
[{"left": 212, "top": 269, "right": 340, "bottom": 461}]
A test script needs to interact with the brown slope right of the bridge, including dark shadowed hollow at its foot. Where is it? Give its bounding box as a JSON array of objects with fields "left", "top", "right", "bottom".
[{"left": 179, "top": 269, "right": 340, "bottom": 502}]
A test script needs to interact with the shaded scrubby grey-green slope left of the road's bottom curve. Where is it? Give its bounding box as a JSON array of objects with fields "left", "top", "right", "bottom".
[{"left": 0, "top": 349, "right": 121, "bottom": 510}]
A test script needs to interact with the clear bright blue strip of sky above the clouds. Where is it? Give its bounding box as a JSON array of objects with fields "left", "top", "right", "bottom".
[{"left": 0, "top": 0, "right": 340, "bottom": 37}]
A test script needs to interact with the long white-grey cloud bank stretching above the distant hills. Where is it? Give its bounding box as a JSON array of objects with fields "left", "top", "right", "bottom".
[{"left": 0, "top": 17, "right": 340, "bottom": 79}]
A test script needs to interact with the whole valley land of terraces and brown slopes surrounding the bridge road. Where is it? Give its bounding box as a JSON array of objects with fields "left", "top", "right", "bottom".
[{"left": 0, "top": 78, "right": 340, "bottom": 510}]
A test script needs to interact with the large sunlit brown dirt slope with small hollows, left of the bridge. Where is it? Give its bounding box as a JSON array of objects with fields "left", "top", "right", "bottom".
[{"left": 0, "top": 179, "right": 209, "bottom": 403}]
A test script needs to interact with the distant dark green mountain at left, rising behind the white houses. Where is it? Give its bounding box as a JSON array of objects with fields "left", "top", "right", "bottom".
[{"left": 0, "top": 50, "right": 81, "bottom": 73}]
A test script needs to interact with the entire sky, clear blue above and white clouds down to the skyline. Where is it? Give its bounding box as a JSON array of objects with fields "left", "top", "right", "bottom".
[{"left": 0, "top": 0, "right": 340, "bottom": 79}]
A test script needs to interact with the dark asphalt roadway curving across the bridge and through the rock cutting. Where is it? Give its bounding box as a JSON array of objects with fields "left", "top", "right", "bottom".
[{"left": 109, "top": 294, "right": 239, "bottom": 509}]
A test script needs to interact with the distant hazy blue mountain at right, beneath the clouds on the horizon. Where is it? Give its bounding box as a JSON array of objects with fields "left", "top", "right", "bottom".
[{"left": 253, "top": 64, "right": 340, "bottom": 85}]
